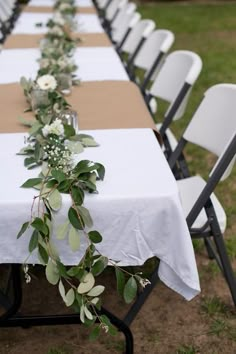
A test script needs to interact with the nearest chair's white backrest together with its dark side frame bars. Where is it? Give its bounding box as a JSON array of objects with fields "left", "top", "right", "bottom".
[{"left": 169, "top": 84, "right": 236, "bottom": 227}]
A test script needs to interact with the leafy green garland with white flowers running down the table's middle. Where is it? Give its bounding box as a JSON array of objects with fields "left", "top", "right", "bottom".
[{"left": 17, "top": 0, "right": 150, "bottom": 339}]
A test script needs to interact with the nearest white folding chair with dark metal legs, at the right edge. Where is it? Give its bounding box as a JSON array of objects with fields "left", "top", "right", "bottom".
[{"left": 169, "top": 84, "right": 236, "bottom": 306}]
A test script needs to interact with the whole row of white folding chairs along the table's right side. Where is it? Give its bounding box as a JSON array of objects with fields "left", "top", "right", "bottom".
[{"left": 95, "top": 0, "right": 236, "bottom": 306}]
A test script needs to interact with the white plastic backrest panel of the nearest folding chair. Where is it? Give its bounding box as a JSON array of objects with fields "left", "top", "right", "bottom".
[{"left": 183, "top": 84, "right": 236, "bottom": 180}]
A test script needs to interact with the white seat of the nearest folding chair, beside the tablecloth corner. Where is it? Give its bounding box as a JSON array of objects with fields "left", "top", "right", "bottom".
[{"left": 177, "top": 176, "right": 226, "bottom": 234}]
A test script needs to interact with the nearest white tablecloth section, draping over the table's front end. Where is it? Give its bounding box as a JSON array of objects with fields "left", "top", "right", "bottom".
[{"left": 0, "top": 129, "right": 200, "bottom": 300}]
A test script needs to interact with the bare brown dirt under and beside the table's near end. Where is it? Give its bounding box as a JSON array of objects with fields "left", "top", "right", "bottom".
[{"left": 0, "top": 255, "right": 236, "bottom": 354}]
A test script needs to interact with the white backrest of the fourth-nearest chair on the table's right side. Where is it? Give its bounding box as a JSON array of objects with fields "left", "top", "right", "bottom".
[{"left": 120, "top": 20, "right": 155, "bottom": 55}]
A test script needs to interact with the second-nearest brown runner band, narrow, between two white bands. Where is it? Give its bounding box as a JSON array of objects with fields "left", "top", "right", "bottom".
[{"left": 3, "top": 33, "right": 112, "bottom": 49}]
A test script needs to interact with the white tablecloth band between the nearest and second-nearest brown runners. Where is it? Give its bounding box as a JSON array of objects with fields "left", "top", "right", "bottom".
[{"left": 0, "top": 47, "right": 129, "bottom": 84}]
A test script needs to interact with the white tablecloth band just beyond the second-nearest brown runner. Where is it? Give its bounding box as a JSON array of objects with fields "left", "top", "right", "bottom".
[{"left": 12, "top": 12, "right": 104, "bottom": 34}]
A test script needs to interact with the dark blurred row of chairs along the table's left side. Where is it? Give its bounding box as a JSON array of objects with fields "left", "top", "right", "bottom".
[{"left": 0, "top": 0, "right": 19, "bottom": 43}]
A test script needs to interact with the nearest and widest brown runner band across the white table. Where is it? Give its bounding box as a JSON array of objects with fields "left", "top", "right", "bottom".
[{"left": 0, "top": 81, "right": 159, "bottom": 133}]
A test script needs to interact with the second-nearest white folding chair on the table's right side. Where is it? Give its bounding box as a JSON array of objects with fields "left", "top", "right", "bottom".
[{"left": 146, "top": 50, "right": 202, "bottom": 156}]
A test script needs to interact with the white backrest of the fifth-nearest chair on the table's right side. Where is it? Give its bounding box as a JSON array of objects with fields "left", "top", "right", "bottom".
[{"left": 112, "top": 12, "right": 141, "bottom": 47}]
